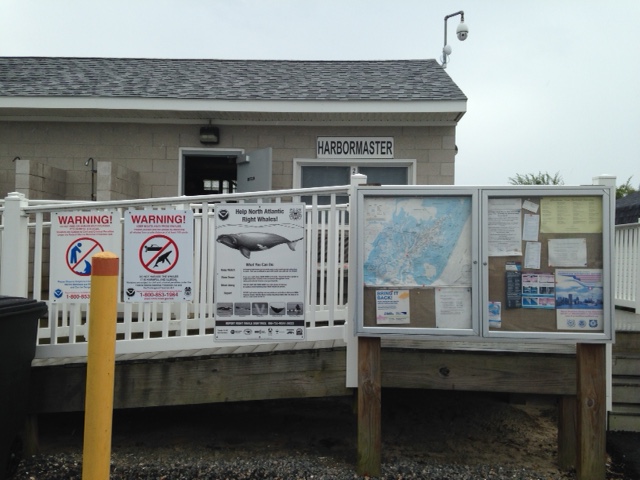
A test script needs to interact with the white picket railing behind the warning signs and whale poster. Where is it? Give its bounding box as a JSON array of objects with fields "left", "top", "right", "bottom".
[{"left": 0, "top": 181, "right": 360, "bottom": 358}]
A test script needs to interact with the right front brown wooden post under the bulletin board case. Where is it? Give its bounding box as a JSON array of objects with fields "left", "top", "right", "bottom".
[{"left": 576, "top": 343, "right": 607, "bottom": 480}]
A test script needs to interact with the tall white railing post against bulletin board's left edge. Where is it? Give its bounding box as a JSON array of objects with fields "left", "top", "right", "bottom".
[{"left": 344, "top": 174, "right": 367, "bottom": 388}]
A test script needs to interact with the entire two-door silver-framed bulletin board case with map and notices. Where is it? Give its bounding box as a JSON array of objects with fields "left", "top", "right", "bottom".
[{"left": 356, "top": 186, "right": 615, "bottom": 343}]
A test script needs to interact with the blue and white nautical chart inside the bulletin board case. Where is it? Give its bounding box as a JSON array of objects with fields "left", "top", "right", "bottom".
[{"left": 364, "top": 197, "right": 471, "bottom": 286}]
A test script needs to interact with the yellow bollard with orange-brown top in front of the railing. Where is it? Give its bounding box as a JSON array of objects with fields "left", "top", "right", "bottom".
[{"left": 82, "top": 252, "right": 118, "bottom": 480}]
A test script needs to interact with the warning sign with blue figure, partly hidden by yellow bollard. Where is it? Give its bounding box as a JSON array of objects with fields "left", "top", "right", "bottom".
[{"left": 49, "top": 210, "right": 121, "bottom": 303}]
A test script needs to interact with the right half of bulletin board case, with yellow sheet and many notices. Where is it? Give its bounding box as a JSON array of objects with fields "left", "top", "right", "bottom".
[{"left": 482, "top": 186, "right": 612, "bottom": 341}]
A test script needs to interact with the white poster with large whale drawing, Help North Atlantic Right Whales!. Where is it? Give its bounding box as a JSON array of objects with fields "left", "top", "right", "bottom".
[{"left": 214, "top": 203, "right": 306, "bottom": 341}]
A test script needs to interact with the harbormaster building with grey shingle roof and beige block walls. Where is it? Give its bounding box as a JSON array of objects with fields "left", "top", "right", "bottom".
[{"left": 0, "top": 57, "right": 467, "bottom": 200}]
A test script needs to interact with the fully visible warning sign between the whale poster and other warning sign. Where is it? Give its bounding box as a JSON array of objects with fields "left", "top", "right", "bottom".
[{"left": 124, "top": 210, "right": 193, "bottom": 302}]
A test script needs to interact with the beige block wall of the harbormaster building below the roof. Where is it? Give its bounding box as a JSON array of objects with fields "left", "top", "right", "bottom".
[{"left": 0, "top": 122, "right": 455, "bottom": 200}]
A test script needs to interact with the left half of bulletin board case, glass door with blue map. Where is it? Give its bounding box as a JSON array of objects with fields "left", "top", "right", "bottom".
[{"left": 357, "top": 187, "right": 480, "bottom": 336}]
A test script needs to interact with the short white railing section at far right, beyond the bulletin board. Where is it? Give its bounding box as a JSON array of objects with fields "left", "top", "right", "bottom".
[{"left": 614, "top": 223, "right": 640, "bottom": 314}]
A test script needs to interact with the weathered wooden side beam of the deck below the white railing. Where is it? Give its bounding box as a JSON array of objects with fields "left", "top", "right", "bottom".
[{"left": 30, "top": 339, "right": 576, "bottom": 414}]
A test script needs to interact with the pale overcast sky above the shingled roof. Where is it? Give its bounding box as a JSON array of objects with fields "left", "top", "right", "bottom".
[{"left": 0, "top": 0, "right": 640, "bottom": 188}]
